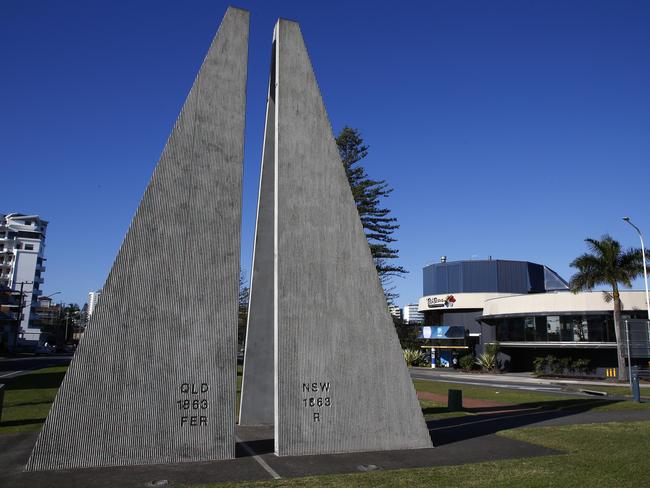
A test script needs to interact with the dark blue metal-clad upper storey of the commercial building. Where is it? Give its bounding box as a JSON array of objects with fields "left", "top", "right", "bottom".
[{"left": 422, "top": 259, "right": 568, "bottom": 296}]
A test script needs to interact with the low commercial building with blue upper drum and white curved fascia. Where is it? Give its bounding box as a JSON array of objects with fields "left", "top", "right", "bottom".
[{"left": 419, "top": 260, "right": 647, "bottom": 370}]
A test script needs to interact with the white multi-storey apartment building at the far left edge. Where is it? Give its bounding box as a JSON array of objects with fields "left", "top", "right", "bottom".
[{"left": 0, "top": 213, "right": 48, "bottom": 345}]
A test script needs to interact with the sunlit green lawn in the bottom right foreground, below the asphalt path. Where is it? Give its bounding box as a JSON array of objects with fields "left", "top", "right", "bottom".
[{"left": 185, "top": 422, "right": 650, "bottom": 488}]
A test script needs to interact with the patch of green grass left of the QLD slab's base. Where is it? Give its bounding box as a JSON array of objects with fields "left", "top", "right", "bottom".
[{"left": 0, "top": 366, "right": 67, "bottom": 434}]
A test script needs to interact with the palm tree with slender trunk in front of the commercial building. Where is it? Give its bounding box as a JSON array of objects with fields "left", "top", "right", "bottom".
[{"left": 569, "top": 234, "right": 643, "bottom": 380}]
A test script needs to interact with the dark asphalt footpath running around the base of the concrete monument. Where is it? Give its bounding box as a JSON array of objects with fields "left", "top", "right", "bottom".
[{"left": 0, "top": 409, "right": 650, "bottom": 488}]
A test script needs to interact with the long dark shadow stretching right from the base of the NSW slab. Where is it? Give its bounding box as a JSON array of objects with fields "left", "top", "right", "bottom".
[{"left": 422, "top": 398, "right": 620, "bottom": 446}]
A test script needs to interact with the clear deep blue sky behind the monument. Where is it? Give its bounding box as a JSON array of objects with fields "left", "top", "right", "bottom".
[{"left": 0, "top": 0, "right": 650, "bottom": 304}]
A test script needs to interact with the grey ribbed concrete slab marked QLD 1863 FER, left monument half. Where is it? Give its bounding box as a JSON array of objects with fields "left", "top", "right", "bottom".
[{"left": 26, "top": 8, "right": 249, "bottom": 470}]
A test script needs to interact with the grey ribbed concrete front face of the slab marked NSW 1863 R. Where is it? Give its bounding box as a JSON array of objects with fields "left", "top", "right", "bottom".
[{"left": 275, "top": 20, "right": 431, "bottom": 455}]
